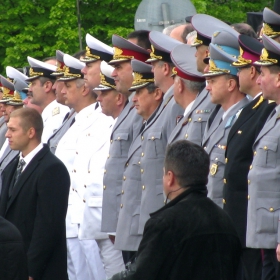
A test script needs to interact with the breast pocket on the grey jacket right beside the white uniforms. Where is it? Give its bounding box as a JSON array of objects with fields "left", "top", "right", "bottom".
[{"left": 110, "top": 132, "right": 130, "bottom": 158}]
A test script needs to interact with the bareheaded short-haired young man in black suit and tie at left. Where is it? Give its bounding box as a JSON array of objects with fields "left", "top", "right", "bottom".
[{"left": 0, "top": 108, "right": 70, "bottom": 280}]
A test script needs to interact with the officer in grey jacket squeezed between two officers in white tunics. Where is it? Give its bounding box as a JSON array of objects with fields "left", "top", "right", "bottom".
[{"left": 48, "top": 50, "right": 76, "bottom": 154}]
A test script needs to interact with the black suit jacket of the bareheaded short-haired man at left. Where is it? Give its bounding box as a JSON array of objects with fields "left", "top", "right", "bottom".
[{"left": 0, "top": 145, "right": 70, "bottom": 280}]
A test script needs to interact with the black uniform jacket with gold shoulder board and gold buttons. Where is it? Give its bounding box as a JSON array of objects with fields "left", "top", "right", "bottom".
[{"left": 223, "top": 95, "right": 276, "bottom": 247}]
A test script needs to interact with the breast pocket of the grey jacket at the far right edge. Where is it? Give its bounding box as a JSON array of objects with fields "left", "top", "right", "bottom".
[{"left": 255, "top": 136, "right": 278, "bottom": 168}]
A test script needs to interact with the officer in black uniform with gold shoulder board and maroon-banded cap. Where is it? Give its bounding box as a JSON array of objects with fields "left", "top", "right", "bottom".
[{"left": 223, "top": 35, "right": 275, "bottom": 280}]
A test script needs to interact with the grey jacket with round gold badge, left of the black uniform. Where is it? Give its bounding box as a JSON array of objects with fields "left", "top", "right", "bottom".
[{"left": 202, "top": 97, "right": 249, "bottom": 208}]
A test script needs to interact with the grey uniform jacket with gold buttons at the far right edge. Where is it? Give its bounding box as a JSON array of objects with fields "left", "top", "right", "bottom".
[{"left": 246, "top": 105, "right": 280, "bottom": 249}]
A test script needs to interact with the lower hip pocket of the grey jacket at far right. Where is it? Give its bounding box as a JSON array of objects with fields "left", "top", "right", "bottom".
[{"left": 256, "top": 192, "right": 280, "bottom": 234}]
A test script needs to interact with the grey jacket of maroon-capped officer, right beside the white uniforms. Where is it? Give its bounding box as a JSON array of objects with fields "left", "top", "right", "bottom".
[{"left": 101, "top": 102, "right": 143, "bottom": 232}]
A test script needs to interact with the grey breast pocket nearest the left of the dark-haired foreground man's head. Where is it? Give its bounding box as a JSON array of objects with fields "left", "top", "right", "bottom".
[{"left": 146, "top": 131, "right": 165, "bottom": 158}]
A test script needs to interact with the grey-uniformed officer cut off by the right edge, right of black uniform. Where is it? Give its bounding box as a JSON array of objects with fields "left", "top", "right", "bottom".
[{"left": 246, "top": 35, "right": 280, "bottom": 279}]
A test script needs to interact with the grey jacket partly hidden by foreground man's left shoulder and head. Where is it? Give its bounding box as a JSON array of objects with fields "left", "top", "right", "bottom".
[{"left": 138, "top": 86, "right": 183, "bottom": 234}]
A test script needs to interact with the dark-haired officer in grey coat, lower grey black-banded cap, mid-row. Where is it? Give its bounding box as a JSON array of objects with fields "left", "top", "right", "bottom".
[{"left": 115, "top": 60, "right": 163, "bottom": 255}]
